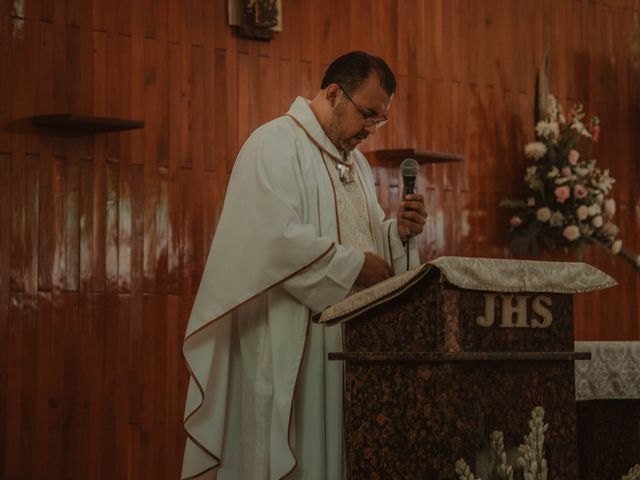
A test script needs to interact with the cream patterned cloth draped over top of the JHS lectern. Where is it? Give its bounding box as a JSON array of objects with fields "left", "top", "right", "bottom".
[{"left": 314, "top": 257, "right": 617, "bottom": 323}]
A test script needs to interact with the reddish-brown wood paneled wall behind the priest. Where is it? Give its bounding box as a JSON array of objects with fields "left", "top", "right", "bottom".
[{"left": 0, "top": 0, "right": 640, "bottom": 480}]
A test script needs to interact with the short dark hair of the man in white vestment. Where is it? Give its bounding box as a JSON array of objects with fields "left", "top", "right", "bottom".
[{"left": 320, "top": 51, "right": 396, "bottom": 95}]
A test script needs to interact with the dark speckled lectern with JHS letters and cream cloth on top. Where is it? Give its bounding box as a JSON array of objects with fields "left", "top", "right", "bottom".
[{"left": 319, "top": 257, "right": 615, "bottom": 480}]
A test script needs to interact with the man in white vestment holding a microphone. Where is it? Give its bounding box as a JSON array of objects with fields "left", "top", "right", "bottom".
[{"left": 182, "top": 52, "right": 427, "bottom": 480}]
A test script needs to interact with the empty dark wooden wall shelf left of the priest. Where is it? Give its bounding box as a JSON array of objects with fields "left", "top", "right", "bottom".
[{"left": 33, "top": 113, "right": 144, "bottom": 133}]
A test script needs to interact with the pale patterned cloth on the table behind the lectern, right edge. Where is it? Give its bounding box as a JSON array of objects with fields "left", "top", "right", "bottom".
[{"left": 575, "top": 342, "right": 640, "bottom": 400}]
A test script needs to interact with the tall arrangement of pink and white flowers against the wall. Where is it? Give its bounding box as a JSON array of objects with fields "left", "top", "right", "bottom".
[{"left": 501, "top": 95, "right": 640, "bottom": 272}]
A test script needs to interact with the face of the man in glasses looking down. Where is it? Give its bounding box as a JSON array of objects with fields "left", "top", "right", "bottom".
[{"left": 327, "top": 74, "right": 393, "bottom": 152}]
